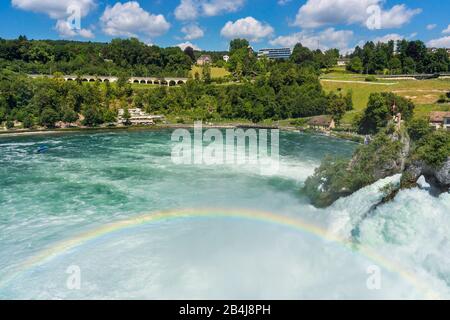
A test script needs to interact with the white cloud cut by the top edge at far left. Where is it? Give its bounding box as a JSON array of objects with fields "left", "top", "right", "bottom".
[{"left": 11, "top": 0, "right": 97, "bottom": 19}]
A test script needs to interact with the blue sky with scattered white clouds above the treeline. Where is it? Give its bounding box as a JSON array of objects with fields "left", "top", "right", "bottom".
[{"left": 0, "top": 0, "right": 450, "bottom": 51}]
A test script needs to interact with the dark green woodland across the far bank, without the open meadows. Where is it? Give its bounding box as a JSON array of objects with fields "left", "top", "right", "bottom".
[{"left": 0, "top": 37, "right": 448, "bottom": 131}]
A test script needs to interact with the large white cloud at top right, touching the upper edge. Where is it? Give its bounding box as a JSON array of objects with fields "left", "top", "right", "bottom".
[{"left": 293, "top": 0, "right": 421, "bottom": 29}]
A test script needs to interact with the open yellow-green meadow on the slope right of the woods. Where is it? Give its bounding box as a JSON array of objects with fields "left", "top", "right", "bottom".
[{"left": 322, "top": 70, "right": 450, "bottom": 124}]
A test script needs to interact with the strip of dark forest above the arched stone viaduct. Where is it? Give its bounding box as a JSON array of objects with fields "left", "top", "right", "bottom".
[{"left": 0, "top": 36, "right": 193, "bottom": 77}]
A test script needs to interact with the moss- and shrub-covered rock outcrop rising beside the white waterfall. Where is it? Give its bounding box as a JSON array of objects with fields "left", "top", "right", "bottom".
[{"left": 304, "top": 125, "right": 450, "bottom": 208}]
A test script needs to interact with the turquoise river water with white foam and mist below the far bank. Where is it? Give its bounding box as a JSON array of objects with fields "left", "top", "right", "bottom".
[{"left": 0, "top": 131, "right": 450, "bottom": 299}]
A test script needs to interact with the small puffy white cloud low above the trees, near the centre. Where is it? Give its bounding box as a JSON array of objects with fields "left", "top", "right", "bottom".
[{"left": 220, "top": 17, "right": 274, "bottom": 41}]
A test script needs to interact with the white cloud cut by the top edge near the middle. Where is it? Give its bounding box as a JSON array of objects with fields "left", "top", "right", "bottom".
[{"left": 175, "top": 0, "right": 245, "bottom": 21}]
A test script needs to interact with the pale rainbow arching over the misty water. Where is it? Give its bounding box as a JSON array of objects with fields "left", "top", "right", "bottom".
[{"left": 0, "top": 209, "right": 440, "bottom": 299}]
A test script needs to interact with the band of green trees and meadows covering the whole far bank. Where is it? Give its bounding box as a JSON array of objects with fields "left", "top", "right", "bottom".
[{"left": 0, "top": 36, "right": 450, "bottom": 136}]
